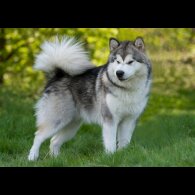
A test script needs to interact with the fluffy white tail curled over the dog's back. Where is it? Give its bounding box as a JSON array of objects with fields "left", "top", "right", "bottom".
[{"left": 34, "top": 37, "right": 94, "bottom": 76}]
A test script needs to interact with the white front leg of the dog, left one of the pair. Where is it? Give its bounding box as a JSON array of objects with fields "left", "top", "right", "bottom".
[{"left": 103, "top": 121, "right": 117, "bottom": 153}]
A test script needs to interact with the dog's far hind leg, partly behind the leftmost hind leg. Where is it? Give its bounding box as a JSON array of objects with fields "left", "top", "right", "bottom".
[{"left": 50, "top": 120, "right": 81, "bottom": 157}]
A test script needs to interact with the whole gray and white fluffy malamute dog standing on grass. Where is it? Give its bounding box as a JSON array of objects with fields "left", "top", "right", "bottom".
[{"left": 28, "top": 37, "right": 152, "bottom": 161}]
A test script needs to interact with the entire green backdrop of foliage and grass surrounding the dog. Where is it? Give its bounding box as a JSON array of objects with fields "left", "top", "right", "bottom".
[{"left": 0, "top": 28, "right": 195, "bottom": 166}]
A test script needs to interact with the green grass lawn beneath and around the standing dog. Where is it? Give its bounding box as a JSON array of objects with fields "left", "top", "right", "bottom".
[{"left": 0, "top": 51, "right": 195, "bottom": 167}]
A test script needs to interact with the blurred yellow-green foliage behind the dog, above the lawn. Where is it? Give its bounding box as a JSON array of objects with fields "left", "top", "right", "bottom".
[{"left": 0, "top": 28, "right": 195, "bottom": 94}]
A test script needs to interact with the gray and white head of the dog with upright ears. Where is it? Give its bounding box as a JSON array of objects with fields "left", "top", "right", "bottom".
[{"left": 106, "top": 37, "right": 151, "bottom": 82}]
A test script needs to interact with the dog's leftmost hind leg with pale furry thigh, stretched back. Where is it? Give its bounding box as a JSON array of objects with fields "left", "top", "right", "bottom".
[{"left": 28, "top": 94, "right": 75, "bottom": 160}]
